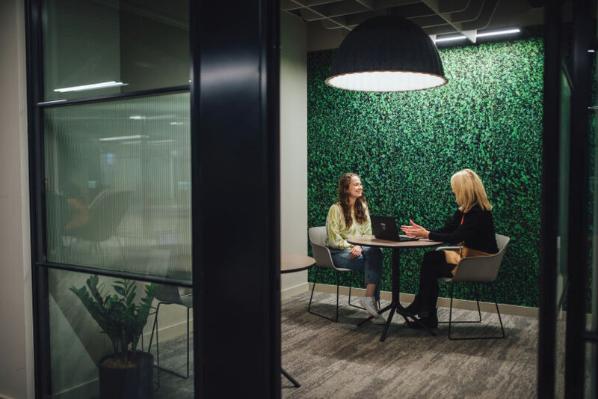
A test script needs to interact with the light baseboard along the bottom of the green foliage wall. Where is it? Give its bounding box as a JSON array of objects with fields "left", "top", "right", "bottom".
[{"left": 309, "top": 282, "right": 538, "bottom": 319}]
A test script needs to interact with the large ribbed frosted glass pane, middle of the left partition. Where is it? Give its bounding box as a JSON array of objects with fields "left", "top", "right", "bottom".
[{"left": 44, "top": 93, "right": 191, "bottom": 280}]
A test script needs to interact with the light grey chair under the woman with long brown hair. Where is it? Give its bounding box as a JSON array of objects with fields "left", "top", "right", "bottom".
[{"left": 307, "top": 226, "right": 376, "bottom": 323}]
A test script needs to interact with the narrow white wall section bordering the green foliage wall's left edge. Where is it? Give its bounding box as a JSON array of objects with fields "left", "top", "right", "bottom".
[{"left": 280, "top": 12, "right": 307, "bottom": 298}]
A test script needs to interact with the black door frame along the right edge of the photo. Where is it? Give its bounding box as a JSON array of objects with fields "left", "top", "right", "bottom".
[{"left": 537, "top": 0, "right": 598, "bottom": 399}]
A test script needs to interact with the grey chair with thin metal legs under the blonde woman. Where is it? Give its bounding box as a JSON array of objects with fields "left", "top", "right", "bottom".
[{"left": 436, "top": 234, "right": 510, "bottom": 341}]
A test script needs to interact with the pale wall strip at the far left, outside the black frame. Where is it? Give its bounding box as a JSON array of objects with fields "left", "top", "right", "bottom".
[{"left": 0, "top": 0, "right": 34, "bottom": 399}]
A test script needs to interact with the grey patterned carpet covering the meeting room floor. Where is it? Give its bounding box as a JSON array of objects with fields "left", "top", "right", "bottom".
[{"left": 155, "top": 293, "right": 538, "bottom": 399}]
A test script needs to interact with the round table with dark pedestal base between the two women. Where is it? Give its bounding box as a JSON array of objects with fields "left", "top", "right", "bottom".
[{"left": 347, "top": 236, "right": 442, "bottom": 341}]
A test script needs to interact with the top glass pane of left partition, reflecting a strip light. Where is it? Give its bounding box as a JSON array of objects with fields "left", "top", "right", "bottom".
[{"left": 43, "top": 0, "right": 190, "bottom": 101}]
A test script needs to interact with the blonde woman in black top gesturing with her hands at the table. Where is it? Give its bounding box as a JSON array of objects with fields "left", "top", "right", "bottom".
[{"left": 401, "top": 169, "right": 498, "bottom": 328}]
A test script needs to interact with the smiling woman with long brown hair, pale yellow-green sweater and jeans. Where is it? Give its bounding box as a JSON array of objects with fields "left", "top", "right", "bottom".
[{"left": 326, "top": 173, "right": 385, "bottom": 323}]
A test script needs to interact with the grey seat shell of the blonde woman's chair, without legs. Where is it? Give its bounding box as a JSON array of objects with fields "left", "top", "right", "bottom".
[{"left": 453, "top": 234, "right": 511, "bottom": 283}]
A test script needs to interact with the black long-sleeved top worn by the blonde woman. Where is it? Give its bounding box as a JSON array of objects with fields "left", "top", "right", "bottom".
[{"left": 430, "top": 205, "right": 498, "bottom": 254}]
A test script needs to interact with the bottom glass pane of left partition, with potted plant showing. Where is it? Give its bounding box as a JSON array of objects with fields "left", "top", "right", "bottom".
[{"left": 48, "top": 270, "right": 194, "bottom": 399}]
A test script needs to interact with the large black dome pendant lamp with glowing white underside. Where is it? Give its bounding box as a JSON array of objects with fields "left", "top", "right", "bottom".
[{"left": 326, "top": 16, "right": 447, "bottom": 92}]
